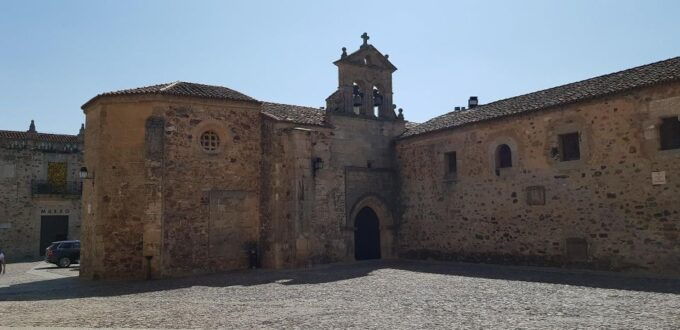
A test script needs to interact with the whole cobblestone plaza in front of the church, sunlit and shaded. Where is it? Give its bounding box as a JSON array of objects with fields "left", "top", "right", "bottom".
[{"left": 0, "top": 261, "right": 680, "bottom": 329}]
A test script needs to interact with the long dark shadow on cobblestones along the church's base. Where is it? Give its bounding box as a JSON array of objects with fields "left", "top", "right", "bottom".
[{"left": 0, "top": 260, "right": 680, "bottom": 301}]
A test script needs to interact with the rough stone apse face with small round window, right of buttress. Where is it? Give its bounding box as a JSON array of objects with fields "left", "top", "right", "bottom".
[{"left": 162, "top": 103, "right": 262, "bottom": 275}]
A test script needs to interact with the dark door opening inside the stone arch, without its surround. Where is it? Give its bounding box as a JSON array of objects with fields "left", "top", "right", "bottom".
[{"left": 354, "top": 207, "right": 380, "bottom": 260}]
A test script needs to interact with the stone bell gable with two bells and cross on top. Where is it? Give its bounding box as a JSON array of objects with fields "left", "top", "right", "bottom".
[{"left": 326, "top": 32, "right": 403, "bottom": 120}]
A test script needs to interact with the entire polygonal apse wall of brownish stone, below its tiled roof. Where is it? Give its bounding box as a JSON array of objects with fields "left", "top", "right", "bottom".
[{"left": 81, "top": 96, "right": 261, "bottom": 278}]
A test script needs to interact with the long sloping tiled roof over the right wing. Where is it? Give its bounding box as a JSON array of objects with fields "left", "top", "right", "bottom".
[{"left": 402, "top": 57, "right": 680, "bottom": 137}]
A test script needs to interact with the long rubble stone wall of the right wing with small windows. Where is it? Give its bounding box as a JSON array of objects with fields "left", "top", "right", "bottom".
[{"left": 397, "top": 84, "right": 680, "bottom": 274}]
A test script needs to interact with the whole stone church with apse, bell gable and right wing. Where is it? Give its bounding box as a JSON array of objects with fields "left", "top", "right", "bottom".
[{"left": 81, "top": 35, "right": 680, "bottom": 278}]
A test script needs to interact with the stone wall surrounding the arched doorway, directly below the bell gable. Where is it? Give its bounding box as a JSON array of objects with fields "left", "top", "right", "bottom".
[{"left": 262, "top": 115, "right": 404, "bottom": 267}]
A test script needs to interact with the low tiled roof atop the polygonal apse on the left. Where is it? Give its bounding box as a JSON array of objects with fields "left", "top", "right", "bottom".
[{"left": 81, "top": 81, "right": 259, "bottom": 109}]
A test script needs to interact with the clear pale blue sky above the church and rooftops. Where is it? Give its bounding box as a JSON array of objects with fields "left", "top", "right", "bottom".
[{"left": 0, "top": 0, "right": 680, "bottom": 134}]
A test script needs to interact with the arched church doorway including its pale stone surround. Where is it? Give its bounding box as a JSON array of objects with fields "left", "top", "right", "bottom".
[{"left": 347, "top": 194, "right": 394, "bottom": 260}]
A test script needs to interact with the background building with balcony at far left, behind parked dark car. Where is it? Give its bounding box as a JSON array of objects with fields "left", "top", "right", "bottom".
[{"left": 0, "top": 121, "right": 84, "bottom": 261}]
